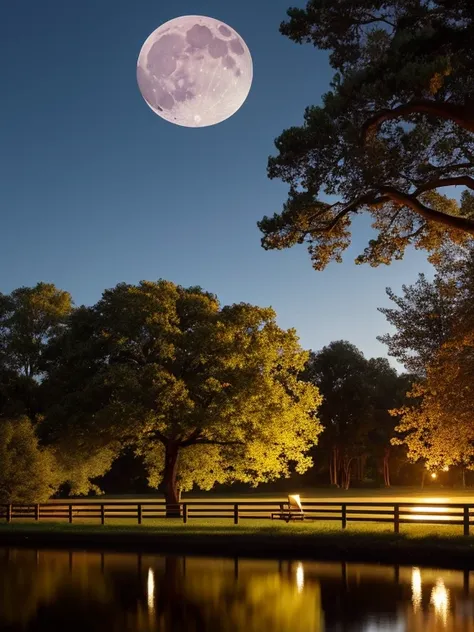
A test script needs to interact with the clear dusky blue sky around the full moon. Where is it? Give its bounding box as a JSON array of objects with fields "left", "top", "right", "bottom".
[{"left": 0, "top": 0, "right": 431, "bottom": 368}]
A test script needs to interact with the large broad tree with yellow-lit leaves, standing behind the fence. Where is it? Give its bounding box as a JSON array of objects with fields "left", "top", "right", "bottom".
[{"left": 43, "top": 281, "right": 321, "bottom": 503}]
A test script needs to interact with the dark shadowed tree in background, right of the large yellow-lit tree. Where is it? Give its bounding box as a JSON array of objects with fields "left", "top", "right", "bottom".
[{"left": 306, "top": 341, "right": 407, "bottom": 488}]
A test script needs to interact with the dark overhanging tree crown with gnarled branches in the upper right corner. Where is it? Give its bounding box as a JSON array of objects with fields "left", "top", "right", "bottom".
[{"left": 259, "top": 0, "right": 474, "bottom": 270}]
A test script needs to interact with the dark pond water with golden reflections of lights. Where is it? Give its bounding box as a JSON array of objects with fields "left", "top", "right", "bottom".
[{"left": 0, "top": 549, "right": 474, "bottom": 632}]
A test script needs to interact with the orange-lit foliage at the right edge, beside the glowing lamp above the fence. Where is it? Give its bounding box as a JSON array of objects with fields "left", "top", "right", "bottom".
[{"left": 394, "top": 251, "right": 474, "bottom": 469}]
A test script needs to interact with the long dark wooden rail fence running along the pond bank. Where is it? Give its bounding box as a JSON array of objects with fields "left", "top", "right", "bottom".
[{"left": 0, "top": 500, "right": 474, "bottom": 535}]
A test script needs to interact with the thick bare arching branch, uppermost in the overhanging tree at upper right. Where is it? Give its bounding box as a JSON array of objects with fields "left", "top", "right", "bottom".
[{"left": 362, "top": 99, "right": 474, "bottom": 143}]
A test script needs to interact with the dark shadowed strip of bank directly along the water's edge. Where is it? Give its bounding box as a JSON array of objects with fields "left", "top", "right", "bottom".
[{"left": 0, "top": 527, "right": 474, "bottom": 570}]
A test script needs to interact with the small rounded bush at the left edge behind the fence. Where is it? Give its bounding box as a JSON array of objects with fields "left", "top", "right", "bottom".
[{"left": 0, "top": 417, "right": 60, "bottom": 504}]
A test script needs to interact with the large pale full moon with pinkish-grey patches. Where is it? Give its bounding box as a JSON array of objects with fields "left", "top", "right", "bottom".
[{"left": 137, "top": 15, "right": 253, "bottom": 127}]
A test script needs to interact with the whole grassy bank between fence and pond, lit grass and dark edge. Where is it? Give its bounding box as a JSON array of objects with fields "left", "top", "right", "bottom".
[{"left": 0, "top": 520, "right": 474, "bottom": 568}]
